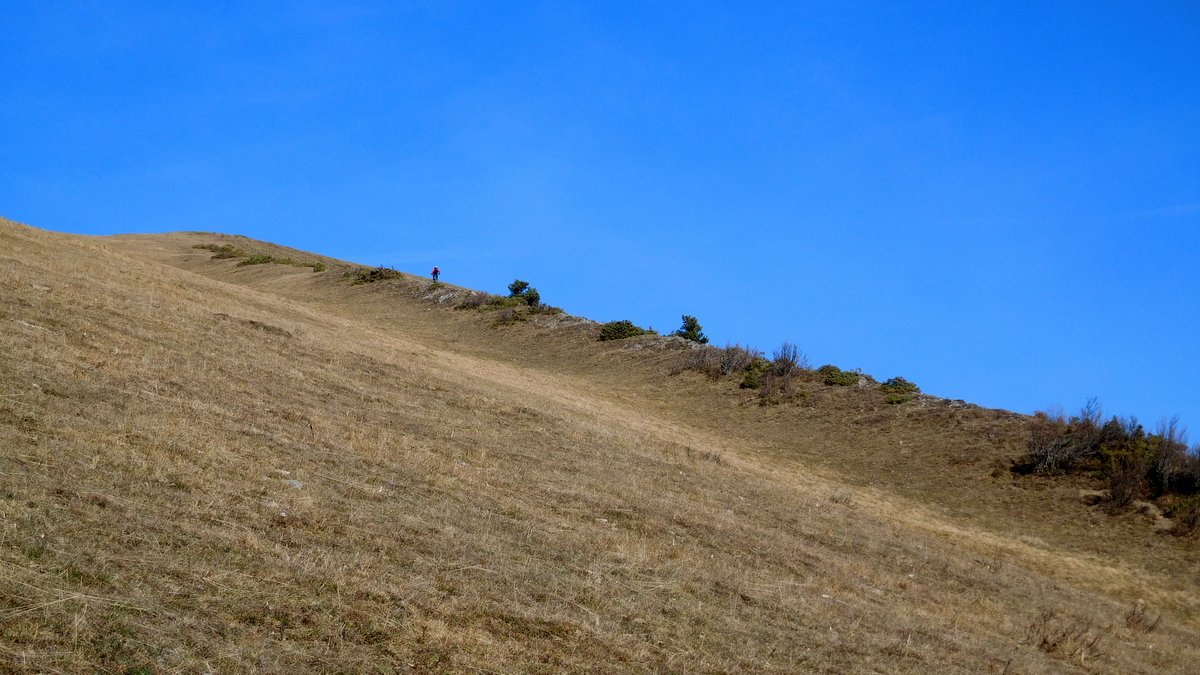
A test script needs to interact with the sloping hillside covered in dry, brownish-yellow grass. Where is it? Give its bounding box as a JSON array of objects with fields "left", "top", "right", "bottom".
[{"left": 0, "top": 221, "right": 1200, "bottom": 673}]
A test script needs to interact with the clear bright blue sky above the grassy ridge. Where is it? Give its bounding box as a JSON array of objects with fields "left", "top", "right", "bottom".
[{"left": 7, "top": 0, "right": 1200, "bottom": 442}]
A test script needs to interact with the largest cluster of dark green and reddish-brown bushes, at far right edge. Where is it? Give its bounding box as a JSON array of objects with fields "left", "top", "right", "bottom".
[{"left": 1013, "top": 399, "right": 1200, "bottom": 534}]
